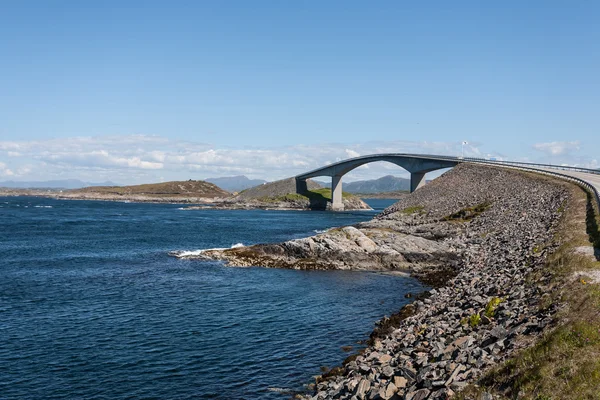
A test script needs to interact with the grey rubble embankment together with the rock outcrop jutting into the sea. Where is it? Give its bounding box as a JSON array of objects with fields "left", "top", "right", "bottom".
[{"left": 180, "top": 165, "right": 570, "bottom": 400}]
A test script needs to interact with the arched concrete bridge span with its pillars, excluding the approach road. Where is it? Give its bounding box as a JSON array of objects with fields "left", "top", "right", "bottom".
[{"left": 296, "top": 153, "right": 461, "bottom": 211}]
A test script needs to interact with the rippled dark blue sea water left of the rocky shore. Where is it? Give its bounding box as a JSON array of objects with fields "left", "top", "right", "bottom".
[{"left": 0, "top": 197, "right": 422, "bottom": 399}]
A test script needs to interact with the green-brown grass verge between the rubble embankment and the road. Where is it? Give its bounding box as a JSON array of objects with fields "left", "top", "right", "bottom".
[{"left": 456, "top": 184, "right": 600, "bottom": 400}]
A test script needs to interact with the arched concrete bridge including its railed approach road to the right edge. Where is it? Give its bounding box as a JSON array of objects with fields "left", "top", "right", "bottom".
[{"left": 296, "top": 153, "right": 600, "bottom": 211}]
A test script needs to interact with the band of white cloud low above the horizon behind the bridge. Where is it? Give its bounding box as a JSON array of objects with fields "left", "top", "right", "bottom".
[{"left": 0, "top": 135, "right": 586, "bottom": 184}]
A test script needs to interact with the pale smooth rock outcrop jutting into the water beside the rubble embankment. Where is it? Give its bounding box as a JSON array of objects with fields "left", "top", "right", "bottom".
[{"left": 195, "top": 226, "right": 459, "bottom": 282}]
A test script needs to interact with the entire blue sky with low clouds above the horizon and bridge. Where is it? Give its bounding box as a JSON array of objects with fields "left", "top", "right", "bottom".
[{"left": 0, "top": 0, "right": 600, "bottom": 183}]
